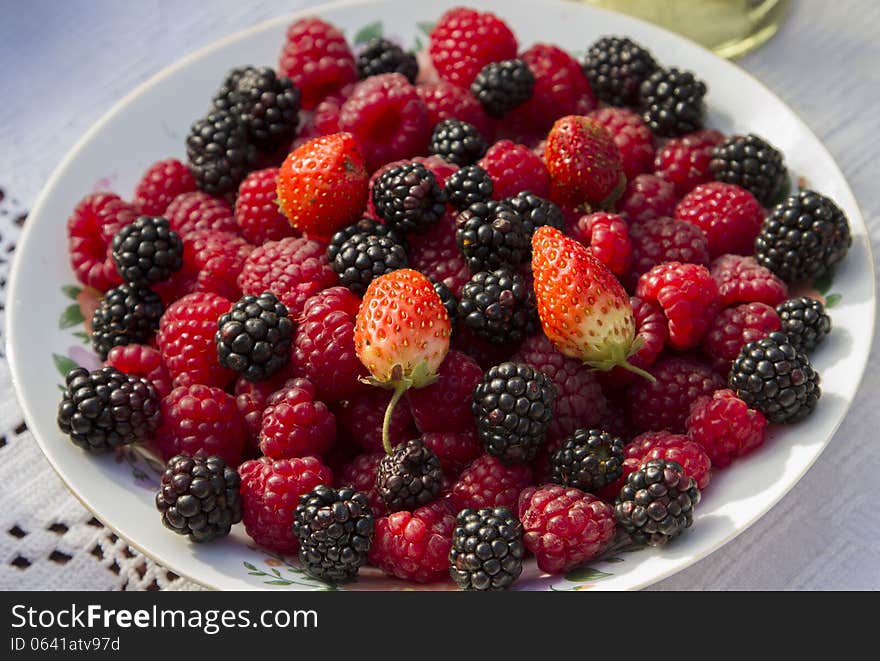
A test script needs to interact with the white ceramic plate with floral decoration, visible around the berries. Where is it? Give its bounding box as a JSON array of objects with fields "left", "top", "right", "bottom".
[{"left": 7, "top": 0, "right": 875, "bottom": 590}]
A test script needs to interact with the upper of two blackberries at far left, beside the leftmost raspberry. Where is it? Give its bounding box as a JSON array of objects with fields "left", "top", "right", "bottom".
[{"left": 111, "top": 216, "right": 183, "bottom": 287}]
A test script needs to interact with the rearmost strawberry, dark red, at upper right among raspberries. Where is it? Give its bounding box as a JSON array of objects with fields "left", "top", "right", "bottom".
[{"left": 544, "top": 115, "right": 626, "bottom": 207}]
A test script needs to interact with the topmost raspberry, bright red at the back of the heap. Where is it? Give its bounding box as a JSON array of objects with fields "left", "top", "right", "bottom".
[{"left": 428, "top": 7, "right": 517, "bottom": 88}]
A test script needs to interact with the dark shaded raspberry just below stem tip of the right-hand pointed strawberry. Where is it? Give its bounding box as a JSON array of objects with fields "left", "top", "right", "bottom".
[{"left": 627, "top": 357, "right": 725, "bottom": 433}]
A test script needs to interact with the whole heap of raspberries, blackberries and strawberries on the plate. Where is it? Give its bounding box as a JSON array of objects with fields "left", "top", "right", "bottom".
[{"left": 58, "top": 7, "right": 851, "bottom": 590}]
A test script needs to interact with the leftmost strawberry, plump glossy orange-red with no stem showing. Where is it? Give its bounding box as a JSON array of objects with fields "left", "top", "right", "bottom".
[{"left": 278, "top": 133, "right": 369, "bottom": 240}]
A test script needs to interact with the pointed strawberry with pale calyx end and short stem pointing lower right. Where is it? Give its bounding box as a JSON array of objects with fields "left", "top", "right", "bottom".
[{"left": 532, "top": 226, "right": 654, "bottom": 381}]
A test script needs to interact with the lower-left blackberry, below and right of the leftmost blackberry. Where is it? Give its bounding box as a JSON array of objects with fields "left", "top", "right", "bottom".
[{"left": 156, "top": 454, "right": 241, "bottom": 542}]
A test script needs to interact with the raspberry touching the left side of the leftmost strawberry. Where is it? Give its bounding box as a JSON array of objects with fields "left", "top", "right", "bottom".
[{"left": 235, "top": 168, "right": 298, "bottom": 246}]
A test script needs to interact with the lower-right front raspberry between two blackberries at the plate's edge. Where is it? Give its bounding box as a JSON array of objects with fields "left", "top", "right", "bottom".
[{"left": 519, "top": 484, "right": 615, "bottom": 574}]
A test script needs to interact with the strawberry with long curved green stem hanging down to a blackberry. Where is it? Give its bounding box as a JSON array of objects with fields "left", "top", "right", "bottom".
[{"left": 354, "top": 269, "right": 452, "bottom": 455}]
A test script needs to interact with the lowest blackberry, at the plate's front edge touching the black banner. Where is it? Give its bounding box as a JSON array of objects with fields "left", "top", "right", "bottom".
[{"left": 449, "top": 507, "right": 525, "bottom": 590}]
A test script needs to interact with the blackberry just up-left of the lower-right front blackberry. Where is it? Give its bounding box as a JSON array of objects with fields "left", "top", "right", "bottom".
[{"left": 550, "top": 429, "right": 625, "bottom": 491}]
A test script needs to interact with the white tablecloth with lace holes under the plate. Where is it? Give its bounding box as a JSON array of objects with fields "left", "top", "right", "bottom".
[{"left": 0, "top": 0, "right": 880, "bottom": 590}]
